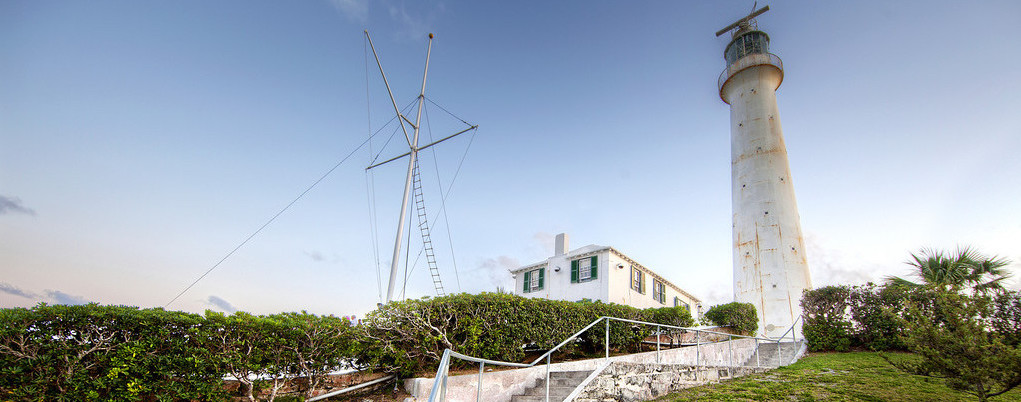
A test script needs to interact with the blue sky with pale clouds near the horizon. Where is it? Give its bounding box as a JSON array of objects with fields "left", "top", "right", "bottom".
[{"left": 0, "top": 0, "right": 1021, "bottom": 315}]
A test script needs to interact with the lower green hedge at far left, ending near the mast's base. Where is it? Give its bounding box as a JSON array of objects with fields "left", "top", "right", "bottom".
[{"left": 0, "top": 304, "right": 356, "bottom": 401}]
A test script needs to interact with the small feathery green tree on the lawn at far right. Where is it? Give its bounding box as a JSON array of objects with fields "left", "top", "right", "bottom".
[{"left": 887, "top": 287, "right": 1021, "bottom": 401}]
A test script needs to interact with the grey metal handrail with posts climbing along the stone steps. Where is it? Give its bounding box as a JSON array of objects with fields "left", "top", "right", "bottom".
[{"left": 429, "top": 315, "right": 800, "bottom": 402}]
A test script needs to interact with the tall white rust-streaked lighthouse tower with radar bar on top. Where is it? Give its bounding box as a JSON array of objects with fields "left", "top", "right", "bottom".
[{"left": 716, "top": 6, "right": 812, "bottom": 337}]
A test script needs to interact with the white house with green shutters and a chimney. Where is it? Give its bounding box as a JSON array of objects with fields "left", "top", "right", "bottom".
[{"left": 511, "top": 234, "right": 701, "bottom": 318}]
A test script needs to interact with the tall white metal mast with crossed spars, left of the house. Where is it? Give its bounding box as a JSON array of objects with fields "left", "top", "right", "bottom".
[{"left": 366, "top": 30, "right": 478, "bottom": 303}]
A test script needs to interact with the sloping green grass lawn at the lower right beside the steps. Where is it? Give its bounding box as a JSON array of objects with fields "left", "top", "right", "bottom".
[{"left": 657, "top": 352, "right": 1021, "bottom": 401}]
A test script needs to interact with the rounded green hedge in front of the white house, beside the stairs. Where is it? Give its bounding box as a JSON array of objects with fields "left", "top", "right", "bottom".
[{"left": 361, "top": 293, "right": 693, "bottom": 375}]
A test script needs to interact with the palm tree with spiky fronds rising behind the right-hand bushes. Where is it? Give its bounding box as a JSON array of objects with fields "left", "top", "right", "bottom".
[{"left": 886, "top": 247, "right": 1011, "bottom": 293}]
